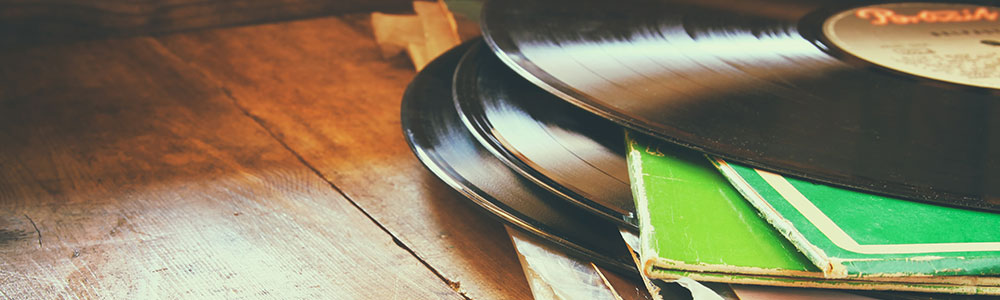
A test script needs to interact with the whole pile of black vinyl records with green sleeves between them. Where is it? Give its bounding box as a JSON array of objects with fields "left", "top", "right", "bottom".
[{"left": 402, "top": 0, "right": 1000, "bottom": 295}]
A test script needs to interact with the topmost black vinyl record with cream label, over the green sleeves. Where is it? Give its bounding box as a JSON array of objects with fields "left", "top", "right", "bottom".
[{"left": 482, "top": 0, "right": 1000, "bottom": 211}]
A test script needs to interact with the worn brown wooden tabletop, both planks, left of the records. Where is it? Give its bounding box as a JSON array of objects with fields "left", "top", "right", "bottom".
[{"left": 0, "top": 15, "right": 531, "bottom": 299}]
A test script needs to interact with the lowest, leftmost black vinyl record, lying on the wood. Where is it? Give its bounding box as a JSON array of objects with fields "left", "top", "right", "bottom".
[{"left": 401, "top": 41, "right": 638, "bottom": 276}]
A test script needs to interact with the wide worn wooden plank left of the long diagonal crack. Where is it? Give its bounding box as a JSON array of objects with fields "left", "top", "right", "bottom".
[{"left": 0, "top": 34, "right": 463, "bottom": 299}]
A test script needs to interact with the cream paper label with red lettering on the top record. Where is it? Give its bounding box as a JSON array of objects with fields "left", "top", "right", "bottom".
[{"left": 823, "top": 3, "right": 1000, "bottom": 89}]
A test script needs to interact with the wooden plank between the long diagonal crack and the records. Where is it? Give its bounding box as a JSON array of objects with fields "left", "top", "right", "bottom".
[{"left": 152, "top": 15, "right": 531, "bottom": 299}]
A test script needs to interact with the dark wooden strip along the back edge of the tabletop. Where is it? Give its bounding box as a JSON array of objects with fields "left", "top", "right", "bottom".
[{"left": 0, "top": 0, "right": 411, "bottom": 47}]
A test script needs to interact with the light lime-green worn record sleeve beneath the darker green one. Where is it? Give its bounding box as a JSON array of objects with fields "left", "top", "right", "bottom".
[{"left": 626, "top": 132, "right": 1000, "bottom": 295}]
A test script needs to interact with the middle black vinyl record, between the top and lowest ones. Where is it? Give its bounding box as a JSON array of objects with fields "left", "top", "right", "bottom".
[{"left": 454, "top": 44, "right": 638, "bottom": 231}]
